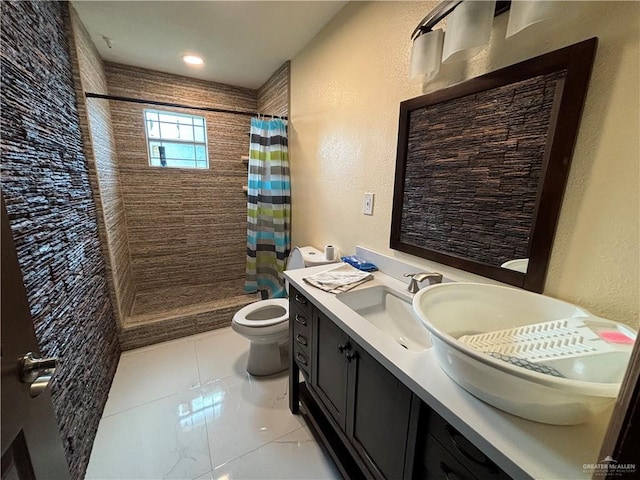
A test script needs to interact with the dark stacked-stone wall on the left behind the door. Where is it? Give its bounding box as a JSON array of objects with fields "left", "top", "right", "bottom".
[{"left": 1, "top": 1, "right": 119, "bottom": 479}]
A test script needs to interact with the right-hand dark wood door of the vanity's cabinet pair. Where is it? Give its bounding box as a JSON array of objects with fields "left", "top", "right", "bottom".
[{"left": 347, "top": 347, "right": 418, "bottom": 479}]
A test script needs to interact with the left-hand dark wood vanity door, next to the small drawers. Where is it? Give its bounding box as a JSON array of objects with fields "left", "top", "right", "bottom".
[{"left": 311, "top": 310, "right": 350, "bottom": 430}]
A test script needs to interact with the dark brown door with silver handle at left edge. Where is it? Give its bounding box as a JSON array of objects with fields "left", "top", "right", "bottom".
[{"left": 0, "top": 199, "right": 69, "bottom": 480}]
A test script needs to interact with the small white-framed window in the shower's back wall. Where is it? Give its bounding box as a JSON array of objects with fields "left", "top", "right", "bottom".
[{"left": 144, "top": 110, "right": 209, "bottom": 168}]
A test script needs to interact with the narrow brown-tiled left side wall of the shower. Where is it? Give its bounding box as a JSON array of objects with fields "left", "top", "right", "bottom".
[{"left": 69, "top": 4, "right": 136, "bottom": 325}]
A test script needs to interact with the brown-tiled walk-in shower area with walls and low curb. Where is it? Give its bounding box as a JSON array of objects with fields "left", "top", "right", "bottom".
[{"left": 75, "top": 30, "right": 289, "bottom": 350}]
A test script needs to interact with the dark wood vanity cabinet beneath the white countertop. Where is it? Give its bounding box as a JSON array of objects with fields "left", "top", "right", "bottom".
[{"left": 289, "top": 286, "right": 509, "bottom": 480}]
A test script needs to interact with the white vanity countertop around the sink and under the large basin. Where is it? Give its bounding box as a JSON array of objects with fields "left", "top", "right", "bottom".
[{"left": 285, "top": 265, "right": 613, "bottom": 480}]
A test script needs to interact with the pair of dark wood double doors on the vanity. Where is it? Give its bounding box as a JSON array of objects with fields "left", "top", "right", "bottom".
[{"left": 311, "top": 311, "right": 419, "bottom": 479}]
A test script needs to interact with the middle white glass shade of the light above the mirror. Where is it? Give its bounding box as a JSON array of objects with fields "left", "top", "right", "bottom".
[{"left": 442, "top": 0, "right": 496, "bottom": 63}]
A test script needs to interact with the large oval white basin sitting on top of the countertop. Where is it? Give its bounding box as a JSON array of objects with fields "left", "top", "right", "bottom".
[{"left": 413, "top": 282, "right": 635, "bottom": 425}]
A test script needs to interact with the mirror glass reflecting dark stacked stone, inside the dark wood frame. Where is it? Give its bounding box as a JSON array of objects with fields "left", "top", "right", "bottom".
[{"left": 400, "top": 71, "right": 566, "bottom": 266}]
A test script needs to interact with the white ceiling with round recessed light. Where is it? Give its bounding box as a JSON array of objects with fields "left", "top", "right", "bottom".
[{"left": 72, "top": 0, "right": 347, "bottom": 89}]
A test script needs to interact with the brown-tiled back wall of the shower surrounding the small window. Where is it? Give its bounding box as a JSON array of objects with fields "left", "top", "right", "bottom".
[{"left": 106, "top": 63, "right": 256, "bottom": 292}]
